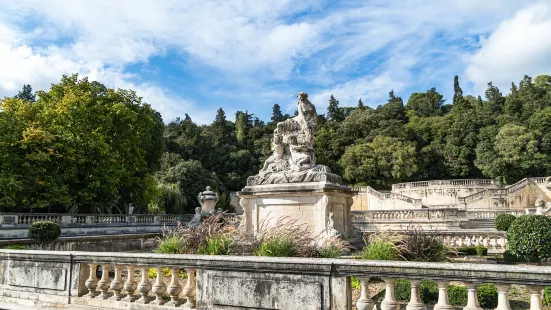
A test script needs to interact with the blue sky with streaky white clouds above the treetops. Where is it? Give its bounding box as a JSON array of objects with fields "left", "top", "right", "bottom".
[{"left": 0, "top": 0, "right": 551, "bottom": 124}]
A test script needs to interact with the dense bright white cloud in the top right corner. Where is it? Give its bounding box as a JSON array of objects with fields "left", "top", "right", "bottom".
[{"left": 465, "top": 3, "right": 551, "bottom": 93}]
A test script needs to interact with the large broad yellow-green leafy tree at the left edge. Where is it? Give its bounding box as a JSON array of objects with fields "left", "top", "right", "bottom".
[{"left": 0, "top": 75, "right": 164, "bottom": 213}]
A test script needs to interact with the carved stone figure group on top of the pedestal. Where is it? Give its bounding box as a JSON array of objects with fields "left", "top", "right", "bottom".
[{"left": 247, "top": 92, "right": 343, "bottom": 186}]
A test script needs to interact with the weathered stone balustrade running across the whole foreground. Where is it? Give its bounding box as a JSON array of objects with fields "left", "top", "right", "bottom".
[{"left": 0, "top": 250, "right": 551, "bottom": 310}]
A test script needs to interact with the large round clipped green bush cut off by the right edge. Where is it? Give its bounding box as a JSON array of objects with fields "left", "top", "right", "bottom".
[{"left": 507, "top": 215, "right": 551, "bottom": 259}]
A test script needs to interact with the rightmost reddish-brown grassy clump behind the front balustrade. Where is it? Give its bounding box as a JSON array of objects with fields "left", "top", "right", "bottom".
[{"left": 398, "top": 226, "right": 448, "bottom": 262}]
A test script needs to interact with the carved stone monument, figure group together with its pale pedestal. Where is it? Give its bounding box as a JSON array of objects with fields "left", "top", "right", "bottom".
[{"left": 239, "top": 92, "right": 352, "bottom": 237}]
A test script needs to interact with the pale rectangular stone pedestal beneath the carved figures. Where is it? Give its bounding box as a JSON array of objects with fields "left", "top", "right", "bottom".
[{"left": 238, "top": 181, "right": 353, "bottom": 240}]
